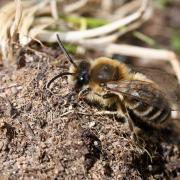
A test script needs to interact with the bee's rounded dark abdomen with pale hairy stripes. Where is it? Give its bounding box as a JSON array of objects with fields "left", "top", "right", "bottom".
[{"left": 125, "top": 84, "right": 171, "bottom": 125}]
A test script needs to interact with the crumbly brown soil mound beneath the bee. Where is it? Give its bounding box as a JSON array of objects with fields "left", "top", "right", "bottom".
[{"left": 0, "top": 0, "right": 180, "bottom": 180}]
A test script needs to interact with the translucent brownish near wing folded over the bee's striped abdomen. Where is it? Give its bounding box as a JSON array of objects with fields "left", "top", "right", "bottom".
[{"left": 106, "top": 80, "right": 180, "bottom": 110}]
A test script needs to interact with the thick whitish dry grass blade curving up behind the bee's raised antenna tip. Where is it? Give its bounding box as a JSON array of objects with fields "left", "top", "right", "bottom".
[{"left": 37, "top": 0, "right": 148, "bottom": 42}]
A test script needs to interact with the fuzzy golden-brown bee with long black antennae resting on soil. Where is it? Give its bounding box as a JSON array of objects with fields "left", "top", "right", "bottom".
[{"left": 47, "top": 35, "right": 177, "bottom": 134}]
